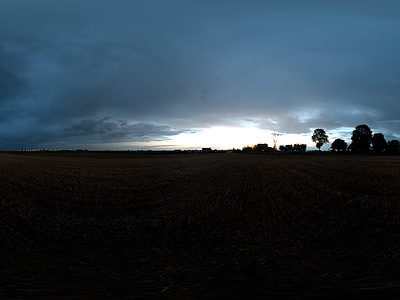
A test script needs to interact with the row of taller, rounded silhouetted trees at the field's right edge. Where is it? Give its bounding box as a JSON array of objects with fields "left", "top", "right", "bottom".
[{"left": 311, "top": 124, "right": 400, "bottom": 154}]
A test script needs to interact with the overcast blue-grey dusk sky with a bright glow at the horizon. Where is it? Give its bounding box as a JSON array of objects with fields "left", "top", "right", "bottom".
[{"left": 0, "top": 0, "right": 400, "bottom": 150}]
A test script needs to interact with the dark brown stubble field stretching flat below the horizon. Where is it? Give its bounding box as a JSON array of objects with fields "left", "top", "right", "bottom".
[{"left": 0, "top": 152, "right": 400, "bottom": 298}]
